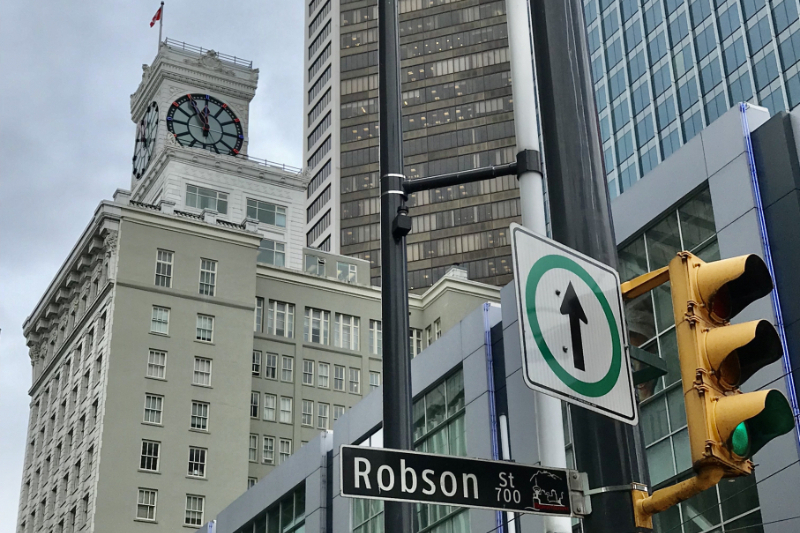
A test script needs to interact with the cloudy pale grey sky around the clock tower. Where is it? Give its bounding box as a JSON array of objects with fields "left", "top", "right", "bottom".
[{"left": 0, "top": 0, "right": 305, "bottom": 533}]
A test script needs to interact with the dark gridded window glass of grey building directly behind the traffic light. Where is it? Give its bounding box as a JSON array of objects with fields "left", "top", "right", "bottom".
[{"left": 616, "top": 188, "right": 763, "bottom": 533}]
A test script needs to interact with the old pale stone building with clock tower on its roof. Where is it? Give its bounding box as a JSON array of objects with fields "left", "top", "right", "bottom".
[{"left": 16, "top": 40, "right": 499, "bottom": 533}]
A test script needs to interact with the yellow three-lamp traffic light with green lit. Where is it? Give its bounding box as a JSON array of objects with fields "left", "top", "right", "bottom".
[{"left": 669, "top": 252, "right": 794, "bottom": 477}]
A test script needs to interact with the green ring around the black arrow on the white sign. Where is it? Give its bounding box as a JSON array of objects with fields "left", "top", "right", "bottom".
[{"left": 525, "top": 255, "right": 622, "bottom": 398}]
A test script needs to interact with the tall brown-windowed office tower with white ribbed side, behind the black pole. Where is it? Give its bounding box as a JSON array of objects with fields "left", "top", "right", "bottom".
[{"left": 303, "top": 0, "right": 519, "bottom": 291}]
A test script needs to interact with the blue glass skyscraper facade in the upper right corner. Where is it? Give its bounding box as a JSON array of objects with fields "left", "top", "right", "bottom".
[{"left": 584, "top": 0, "right": 800, "bottom": 198}]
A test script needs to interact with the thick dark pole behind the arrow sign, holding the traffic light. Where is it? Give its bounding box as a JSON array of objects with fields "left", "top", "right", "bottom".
[{"left": 532, "top": 0, "right": 647, "bottom": 533}]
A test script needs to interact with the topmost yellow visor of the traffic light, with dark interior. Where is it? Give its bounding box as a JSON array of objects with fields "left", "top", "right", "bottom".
[{"left": 697, "top": 254, "right": 772, "bottom": 320}]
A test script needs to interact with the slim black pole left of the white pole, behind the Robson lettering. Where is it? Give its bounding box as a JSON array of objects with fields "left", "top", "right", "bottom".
[{"left": 378, "top": 0, "right": 413, "bottom": 533}]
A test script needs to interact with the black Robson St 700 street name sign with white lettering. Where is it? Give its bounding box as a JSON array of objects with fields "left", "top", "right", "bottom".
[{"left": 339, "top": 446, "right": 591, "bottom": 516}]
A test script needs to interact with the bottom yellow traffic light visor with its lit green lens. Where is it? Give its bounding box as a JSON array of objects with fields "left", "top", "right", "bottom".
[{"left": 716, "top": 390, "right": 794, "bottom": 459}]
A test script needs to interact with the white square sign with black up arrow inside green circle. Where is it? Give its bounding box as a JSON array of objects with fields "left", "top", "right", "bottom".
[{"left": 511, "top": 224, "right": 638, "bottom": 425}]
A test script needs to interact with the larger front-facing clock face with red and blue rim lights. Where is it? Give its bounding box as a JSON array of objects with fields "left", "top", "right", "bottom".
[{"left": 167, "top": 93, "right": 244, "bottom": 155}]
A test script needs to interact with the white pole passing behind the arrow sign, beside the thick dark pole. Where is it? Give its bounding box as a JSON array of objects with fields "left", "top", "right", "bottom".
[{"left": 506, "top": 0, "right": 572, "bottom": 533}]
